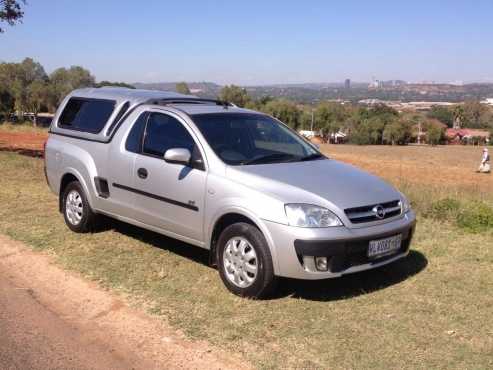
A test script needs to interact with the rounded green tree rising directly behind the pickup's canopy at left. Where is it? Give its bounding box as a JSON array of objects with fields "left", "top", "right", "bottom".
[{"left": 50, "top": 66, "right": 95, "bottom": 104}]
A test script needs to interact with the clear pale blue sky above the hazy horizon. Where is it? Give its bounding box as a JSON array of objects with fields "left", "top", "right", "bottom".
[{"left": 0, "top": 0, "right": 493, "bottom": 85}]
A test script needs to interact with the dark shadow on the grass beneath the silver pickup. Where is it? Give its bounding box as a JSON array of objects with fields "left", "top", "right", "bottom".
[{"left": 96, "top": 217, "right": 428, "bottom": 302}]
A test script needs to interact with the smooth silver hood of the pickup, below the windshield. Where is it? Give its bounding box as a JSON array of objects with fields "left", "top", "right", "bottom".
[{"left": 227, "top": 159, "right": 400, "bottom": 210}]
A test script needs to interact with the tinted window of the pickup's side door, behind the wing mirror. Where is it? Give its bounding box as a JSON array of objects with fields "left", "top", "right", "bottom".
[{"left": 143, "top": 113, "right": 195, "bottom": 157}]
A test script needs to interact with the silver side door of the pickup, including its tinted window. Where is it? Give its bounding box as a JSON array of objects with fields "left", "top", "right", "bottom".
[{"left": 134, "top": 112, "right": 207, "bottom": 242}]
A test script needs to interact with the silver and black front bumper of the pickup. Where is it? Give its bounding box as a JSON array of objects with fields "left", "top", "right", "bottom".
[{"left": 265, "top": 211, "right": 416, "bottom": 280}]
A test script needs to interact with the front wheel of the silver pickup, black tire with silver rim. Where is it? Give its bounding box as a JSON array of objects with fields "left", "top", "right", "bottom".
[{"left": 217, "top": 222, "right": 277, "bottom": 299}]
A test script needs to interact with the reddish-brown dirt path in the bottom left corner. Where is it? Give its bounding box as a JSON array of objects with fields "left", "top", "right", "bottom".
[{"left": 0, "top": 235, "right": 247, "bottom": 369}]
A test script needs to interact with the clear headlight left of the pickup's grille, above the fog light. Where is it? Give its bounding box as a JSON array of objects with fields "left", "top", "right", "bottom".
[{"left": 284, "top": 204, "right": 342, "bottom": 227}]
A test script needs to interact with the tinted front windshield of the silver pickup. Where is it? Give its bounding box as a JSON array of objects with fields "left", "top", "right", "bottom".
[{"left": 192, "top": 113, "right": 325, "bottom": 165}]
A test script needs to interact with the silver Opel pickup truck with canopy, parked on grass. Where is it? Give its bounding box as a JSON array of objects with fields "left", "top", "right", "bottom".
[{"left": 45, "top": 87, "right": 415, "bottom": 298}]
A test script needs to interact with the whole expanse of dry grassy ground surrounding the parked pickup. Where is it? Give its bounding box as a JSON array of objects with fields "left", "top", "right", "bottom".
[{"left": 0, "top": 146, "right": 493, "bottom": 369}]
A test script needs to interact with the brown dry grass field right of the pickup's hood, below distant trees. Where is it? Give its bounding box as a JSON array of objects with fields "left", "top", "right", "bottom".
[{"left": 322, "top": 145, "right": 493, "bottom": 198}]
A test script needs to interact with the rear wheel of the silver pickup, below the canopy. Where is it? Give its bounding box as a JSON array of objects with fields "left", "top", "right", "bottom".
[{"left": 62, "top": 181, "right": 97, "bottom": 233}]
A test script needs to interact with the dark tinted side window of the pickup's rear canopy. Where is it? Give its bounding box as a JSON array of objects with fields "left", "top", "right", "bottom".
[{"left": 58, "top": 98, "right": 115, "bottom": 133}]
